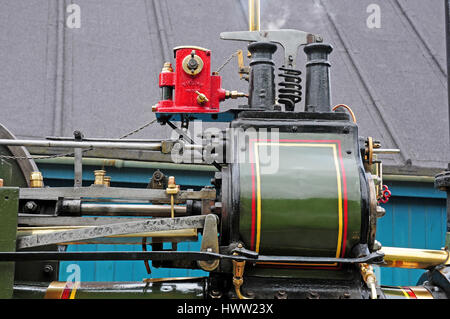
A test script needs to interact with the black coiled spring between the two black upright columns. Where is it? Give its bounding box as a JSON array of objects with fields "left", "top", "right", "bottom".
[{"left": 278, "top": 66, "right": 302, "bottom": 111}]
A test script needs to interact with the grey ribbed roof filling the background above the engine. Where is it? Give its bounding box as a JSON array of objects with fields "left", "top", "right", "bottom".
[{"left": 0, "top": 0, "right": 450, "bottom": 173}]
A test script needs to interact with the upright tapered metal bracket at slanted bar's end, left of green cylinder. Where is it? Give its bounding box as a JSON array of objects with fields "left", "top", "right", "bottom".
[{"left": 197, "top": 214, "right": 220, "bottom": 271}]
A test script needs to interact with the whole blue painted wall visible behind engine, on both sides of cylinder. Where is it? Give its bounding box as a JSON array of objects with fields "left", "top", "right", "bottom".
[{"left": 38, "top": 164, "right": 446, "bottom": 286}]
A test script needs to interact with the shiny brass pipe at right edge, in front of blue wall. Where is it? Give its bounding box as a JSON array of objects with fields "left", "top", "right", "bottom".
[{"left": 380, "top": 247, "right": 450, "bottom": 269}]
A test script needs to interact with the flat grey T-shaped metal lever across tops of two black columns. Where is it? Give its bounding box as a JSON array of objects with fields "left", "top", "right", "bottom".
[{"left": 220, "top": 29, "right": 323, "bottom": 68}]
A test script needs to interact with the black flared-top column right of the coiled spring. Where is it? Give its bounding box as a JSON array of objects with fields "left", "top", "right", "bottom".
[{"left": 304, "top": 43, "right": 333, "bottom": 113}]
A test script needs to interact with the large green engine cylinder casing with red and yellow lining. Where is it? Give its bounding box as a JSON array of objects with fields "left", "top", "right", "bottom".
[{"left": 220, "top": 112, "right": 375, "bottom": 267}]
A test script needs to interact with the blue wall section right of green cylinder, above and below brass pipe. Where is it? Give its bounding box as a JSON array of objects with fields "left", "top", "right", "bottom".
[{"left": 377, "top": 183, "right": 447, "bottom": 286}]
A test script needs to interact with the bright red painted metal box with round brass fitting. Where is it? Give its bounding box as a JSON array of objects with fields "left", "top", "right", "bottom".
[{"left": 153, "top": 46, "right": 226, "bottom": 113}]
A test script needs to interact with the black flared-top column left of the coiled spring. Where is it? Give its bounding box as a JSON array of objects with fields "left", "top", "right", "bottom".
[{"left": 248, "top": 42, "right": 277, "bottom": 111}]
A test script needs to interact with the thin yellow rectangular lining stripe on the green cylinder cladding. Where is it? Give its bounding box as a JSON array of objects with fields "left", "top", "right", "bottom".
[{"left": 254, "top": 142, "right": 343, "bottom": 266}]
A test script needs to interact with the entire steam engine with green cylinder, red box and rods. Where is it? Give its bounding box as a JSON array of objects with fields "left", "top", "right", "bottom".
[{"left": 0, "top": 25, "right": 450, "bottom": 299}]
